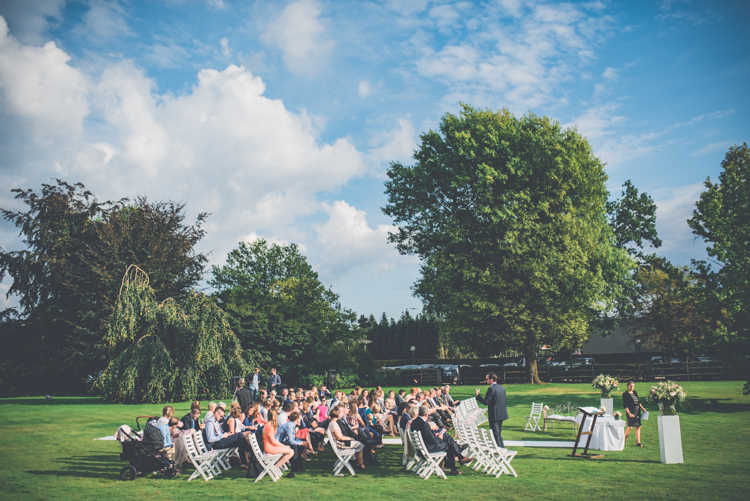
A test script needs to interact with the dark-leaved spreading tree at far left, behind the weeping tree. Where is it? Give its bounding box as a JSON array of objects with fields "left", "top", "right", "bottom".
[{"left": 0, "top": 180, "right": 206, "bottom": 393}]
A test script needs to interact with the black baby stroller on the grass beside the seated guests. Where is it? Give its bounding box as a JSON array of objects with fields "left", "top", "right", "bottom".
[{"left": 120, "top": 416, "right": 177, "bottom": 480}]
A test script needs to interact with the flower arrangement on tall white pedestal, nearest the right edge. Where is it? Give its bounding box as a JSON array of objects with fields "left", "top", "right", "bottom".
[{"left": 646, "top": 381, "right": 687, "bottom": 464}]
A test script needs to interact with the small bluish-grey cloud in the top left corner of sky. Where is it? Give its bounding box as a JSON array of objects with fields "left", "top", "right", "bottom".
[{"left": 0, "top": 0, "right": 65, "bottom": 45}]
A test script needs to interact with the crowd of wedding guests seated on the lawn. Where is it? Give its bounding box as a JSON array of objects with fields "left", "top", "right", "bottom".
[{"left": 142, "top": 382, "right": 471, "bottom": 478}]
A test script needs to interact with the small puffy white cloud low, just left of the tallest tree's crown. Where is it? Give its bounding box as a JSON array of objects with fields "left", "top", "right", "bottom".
[{"left": 314, "top": 200, "right": 406, "bottom": 276}]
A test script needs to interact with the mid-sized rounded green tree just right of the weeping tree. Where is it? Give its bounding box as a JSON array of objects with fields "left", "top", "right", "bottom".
[{"left": 209, "top": 239, "right": 362, "bottom": 379}]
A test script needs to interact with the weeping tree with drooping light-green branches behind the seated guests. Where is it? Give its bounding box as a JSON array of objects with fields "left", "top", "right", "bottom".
[{"left": 94, "top": 265, "right": 254, "bottom": 403}]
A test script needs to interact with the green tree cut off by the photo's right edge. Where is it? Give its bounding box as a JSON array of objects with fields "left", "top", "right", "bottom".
[{"left": 688, "top": 143, "right": 750, "bottom": 391}]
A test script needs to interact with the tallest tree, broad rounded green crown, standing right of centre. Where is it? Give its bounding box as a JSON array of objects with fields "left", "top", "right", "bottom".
[{"left": 383, "top": 106, "right": 632, "bottom": 382}]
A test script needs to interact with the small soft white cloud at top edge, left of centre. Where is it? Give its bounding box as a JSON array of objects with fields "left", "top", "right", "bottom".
[{"left": 261, "top": 0, "right": 335, "bottom": 73}]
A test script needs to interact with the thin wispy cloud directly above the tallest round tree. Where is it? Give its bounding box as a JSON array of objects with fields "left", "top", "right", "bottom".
[{"left": 412, "top": 3, "right": 612, "bottom": 112}]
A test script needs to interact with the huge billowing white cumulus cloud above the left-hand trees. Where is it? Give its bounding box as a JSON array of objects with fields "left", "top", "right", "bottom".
[{"left": 0, "top": 30, "right": 369, "bottom": 282}]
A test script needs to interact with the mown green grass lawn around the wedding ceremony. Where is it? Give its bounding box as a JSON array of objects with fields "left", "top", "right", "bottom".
[{"left": 0, "top": 381, "right": 750, "bottom": 500}]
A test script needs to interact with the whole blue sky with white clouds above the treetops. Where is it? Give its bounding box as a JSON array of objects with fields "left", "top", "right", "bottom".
[{"left": 0, "top": 0, "right": 750, "bottom": 318}]
